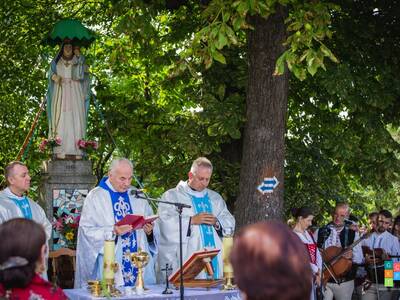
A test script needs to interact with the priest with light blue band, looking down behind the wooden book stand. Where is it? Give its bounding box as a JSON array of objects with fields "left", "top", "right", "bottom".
[{"left": 157, "top": 157, "right": 235, "bottom": 282}]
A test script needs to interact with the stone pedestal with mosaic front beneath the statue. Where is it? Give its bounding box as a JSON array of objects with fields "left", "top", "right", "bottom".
[{"left": 39, "top": 160, "right": 97, "bottom": 250}]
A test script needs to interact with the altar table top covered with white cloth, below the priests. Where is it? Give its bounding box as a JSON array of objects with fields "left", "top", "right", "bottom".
[{"left": 64, "top": 285, "right": 242, "bottom": 300}]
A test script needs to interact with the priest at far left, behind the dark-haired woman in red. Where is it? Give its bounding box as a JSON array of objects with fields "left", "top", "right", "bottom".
[{"left": 0, "top": 161, "right": 51, "bottom": 240}]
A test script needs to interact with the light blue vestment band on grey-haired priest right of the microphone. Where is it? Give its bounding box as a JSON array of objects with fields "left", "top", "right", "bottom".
[{"left": 190, "top": 193, "right": 219, "bottom": 279}]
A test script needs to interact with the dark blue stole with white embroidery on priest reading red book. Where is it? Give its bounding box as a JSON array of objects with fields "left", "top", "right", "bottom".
[{"left": 99, "top": 177, "right": 138, "bottom": 286}]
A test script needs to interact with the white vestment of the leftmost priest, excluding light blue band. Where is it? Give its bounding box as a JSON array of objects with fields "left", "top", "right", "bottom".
[{"left": 0, "top": 188, "right": 51, "bottom": 240}]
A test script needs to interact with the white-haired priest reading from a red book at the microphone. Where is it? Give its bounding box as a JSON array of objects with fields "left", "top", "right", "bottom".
[{"left": 75, "top": 159, "right": 158, "bottom": 288}]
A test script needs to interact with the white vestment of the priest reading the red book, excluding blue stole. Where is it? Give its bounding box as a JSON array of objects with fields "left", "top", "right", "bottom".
[{"left": 75, "top": 180, "right": 158, "bottom": 288}]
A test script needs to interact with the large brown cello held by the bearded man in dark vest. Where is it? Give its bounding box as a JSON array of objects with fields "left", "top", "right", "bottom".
[{"left": 321, "top": 233, "right": 371, "bottom": 285}]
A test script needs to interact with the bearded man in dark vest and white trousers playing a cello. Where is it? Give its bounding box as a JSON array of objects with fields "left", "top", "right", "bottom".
[{"left": 315, "top": 203, "right": 363, "bottom": 300}]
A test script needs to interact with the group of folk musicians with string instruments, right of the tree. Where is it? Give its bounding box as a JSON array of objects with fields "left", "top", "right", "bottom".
[{"left": 292, "top": 203, "right": 400, "bottom": 300}]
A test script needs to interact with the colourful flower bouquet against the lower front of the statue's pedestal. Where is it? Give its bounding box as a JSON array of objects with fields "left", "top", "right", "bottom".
[{"left": 53, "top": 215, "right": 80, "bottom": 249}]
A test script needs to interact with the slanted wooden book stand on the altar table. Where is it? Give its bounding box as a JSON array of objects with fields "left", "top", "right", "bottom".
[{"left": 169, "top": 249, "right": 223, "bottom": 288}]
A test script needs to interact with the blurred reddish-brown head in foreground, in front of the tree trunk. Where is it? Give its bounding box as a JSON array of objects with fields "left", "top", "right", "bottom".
[{"left": 230, "top": 221, "right": 312, "bottom": 300}]
